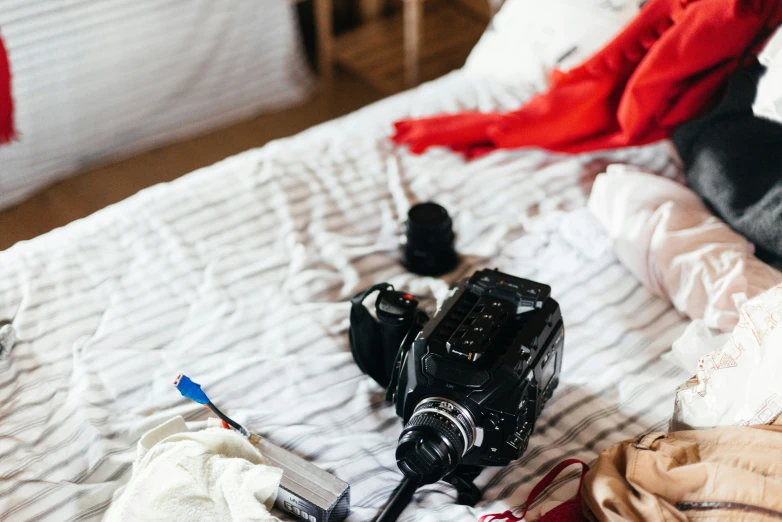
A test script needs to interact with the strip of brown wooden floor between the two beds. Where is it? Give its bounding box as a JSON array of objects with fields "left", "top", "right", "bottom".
[{"left": 0, "top": 71, "right": 383, "bottom": 250}]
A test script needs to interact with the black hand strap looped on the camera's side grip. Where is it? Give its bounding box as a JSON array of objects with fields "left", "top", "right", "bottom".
[{"left": 348, "top": 283, "right": 394, "bottom": 388}]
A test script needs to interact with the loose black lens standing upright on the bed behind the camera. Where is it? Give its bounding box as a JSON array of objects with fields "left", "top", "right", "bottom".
[{"left": 402, "top": 202, "right": 458, "bottom": 276}]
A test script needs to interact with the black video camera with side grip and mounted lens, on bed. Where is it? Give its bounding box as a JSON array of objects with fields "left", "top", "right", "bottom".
[{"left": 350, "top": 270, "right": 565, "bottom": 522}]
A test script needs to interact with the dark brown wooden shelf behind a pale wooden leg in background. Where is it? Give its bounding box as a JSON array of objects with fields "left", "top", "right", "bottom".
[{"left": 334, "top": 2, "right": 486, "bottom": 94}]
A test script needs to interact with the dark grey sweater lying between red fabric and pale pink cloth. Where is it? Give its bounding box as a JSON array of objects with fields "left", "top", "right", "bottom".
[{"left": 673, "top": 64, "right": 782, "bottom": 268}]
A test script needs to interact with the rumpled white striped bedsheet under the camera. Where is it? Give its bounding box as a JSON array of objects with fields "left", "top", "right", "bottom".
[{"left": 0, "top": 72, "right": 685, "bottom": 522}]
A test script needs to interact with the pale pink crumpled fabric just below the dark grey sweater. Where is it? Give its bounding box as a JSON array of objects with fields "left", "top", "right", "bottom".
[{"left": 588, "top": 165, "right": 782, "bottom": 332}]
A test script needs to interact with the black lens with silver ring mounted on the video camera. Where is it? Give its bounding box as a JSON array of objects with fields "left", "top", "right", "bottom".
[{"left": 396, "top": 397, "right": 476, "bottom": 484}]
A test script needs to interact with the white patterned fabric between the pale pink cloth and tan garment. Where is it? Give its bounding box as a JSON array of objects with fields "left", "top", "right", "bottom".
[{"left": 671, "top": 285, "right": 782, "bottom": 431}]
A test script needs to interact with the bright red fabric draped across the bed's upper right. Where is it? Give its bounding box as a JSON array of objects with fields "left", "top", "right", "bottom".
[{"left": 392, "top": 0, "right": 782, "bottom": 158}]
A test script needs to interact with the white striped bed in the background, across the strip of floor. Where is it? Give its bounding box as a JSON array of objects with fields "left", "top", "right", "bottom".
[{"left": 0, "top": 0, "right": 315, "bottom": 209}]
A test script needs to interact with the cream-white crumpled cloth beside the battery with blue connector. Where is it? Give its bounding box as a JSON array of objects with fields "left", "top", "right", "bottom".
[{"left": 104, "top": 417, "right": 282, "bottom": 522}]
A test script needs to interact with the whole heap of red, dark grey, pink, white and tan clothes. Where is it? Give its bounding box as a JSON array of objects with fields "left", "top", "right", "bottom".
[{"left": 392, "top": 0, "right": 782, "bottom": 521}]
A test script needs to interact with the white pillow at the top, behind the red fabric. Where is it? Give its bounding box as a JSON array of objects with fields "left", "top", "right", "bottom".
[{"left": 464, "top": 0, "right": 639, "bottom": 90}]
